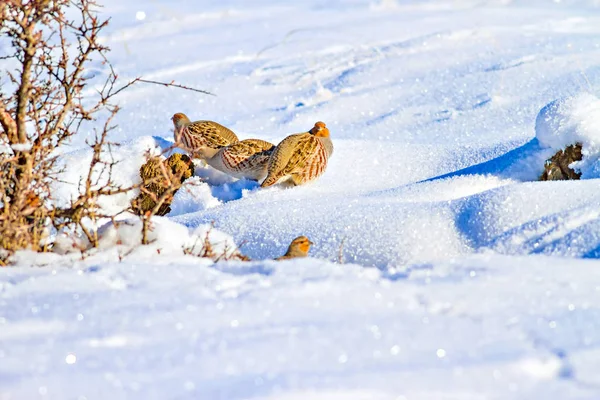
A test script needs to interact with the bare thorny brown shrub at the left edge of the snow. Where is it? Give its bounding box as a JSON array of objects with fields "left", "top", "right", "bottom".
[{"left": 0, "top": 0, "right": 206, "bottom": 264}]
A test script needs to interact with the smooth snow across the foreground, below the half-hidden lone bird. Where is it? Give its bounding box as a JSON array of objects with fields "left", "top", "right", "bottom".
[{"left": 0, "top": 255, "right": 600, "bottom": 399}]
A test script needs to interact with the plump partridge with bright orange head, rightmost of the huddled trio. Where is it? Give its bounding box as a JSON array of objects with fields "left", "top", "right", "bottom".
[{"left": 260, "top": 122, "right": 333, "bottom": 188}]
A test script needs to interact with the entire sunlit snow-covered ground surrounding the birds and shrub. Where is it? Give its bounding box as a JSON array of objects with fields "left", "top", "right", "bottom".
[{"left": 0, "top": 0, "right": 600, "bottom": 400}]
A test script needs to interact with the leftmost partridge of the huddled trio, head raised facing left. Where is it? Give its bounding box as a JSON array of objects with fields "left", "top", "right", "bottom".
[{"left": 171, "top": 113, "right": 239, "bottom": 160}]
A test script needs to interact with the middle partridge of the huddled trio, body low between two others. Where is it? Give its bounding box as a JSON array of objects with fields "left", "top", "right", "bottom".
[{"left": 205, "top": 139, "right": 275, "bottom": 181}]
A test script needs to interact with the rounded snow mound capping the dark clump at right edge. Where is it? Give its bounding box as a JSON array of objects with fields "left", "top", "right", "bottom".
[{"left": 535, "top": 93, "right": 600, "bottom": 179}]
